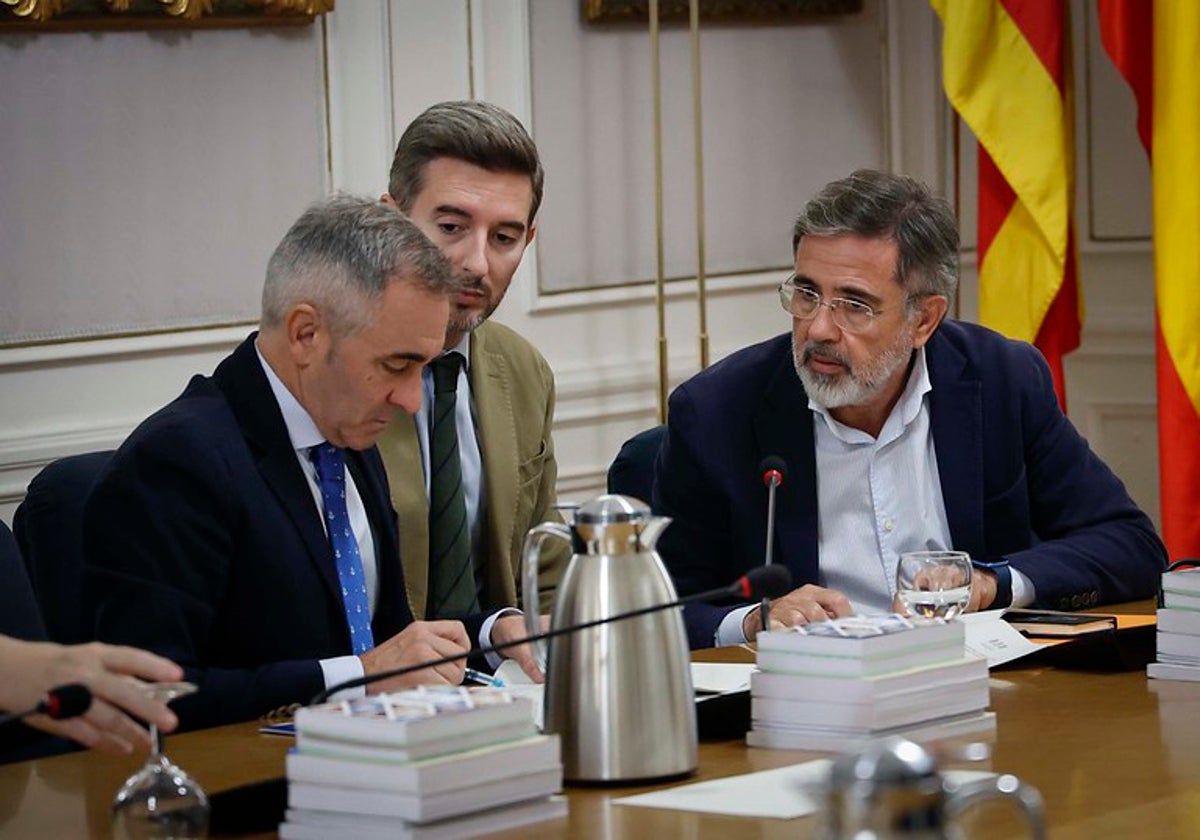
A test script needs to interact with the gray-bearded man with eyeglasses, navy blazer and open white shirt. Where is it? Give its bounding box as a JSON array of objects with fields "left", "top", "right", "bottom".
[{"left": 654, "top": 170, "right": 1166, "bottom": 647}]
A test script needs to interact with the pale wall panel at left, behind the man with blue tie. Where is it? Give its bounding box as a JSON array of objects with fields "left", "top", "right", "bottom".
[{"left": 0, "top": 26, "right": 325, "bottom": 342}]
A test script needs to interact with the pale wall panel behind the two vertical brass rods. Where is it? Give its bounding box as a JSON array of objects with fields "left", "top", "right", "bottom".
[{"left": 530, "top": 0, "right": 884, "bottom": 292}]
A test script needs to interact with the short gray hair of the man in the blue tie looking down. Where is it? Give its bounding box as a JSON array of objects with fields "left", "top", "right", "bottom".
[{"left": 262, "top": 194, "right": 462, "bottom": 338}]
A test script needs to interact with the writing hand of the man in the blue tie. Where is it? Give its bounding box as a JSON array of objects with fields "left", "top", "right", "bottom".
[{"left": 359, "top": 620, "right": 470, "bottom": 692}]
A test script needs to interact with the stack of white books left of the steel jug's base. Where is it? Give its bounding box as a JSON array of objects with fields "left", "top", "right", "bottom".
[{"left": 280, "top": 688, "right": 566, "bottom": 840}]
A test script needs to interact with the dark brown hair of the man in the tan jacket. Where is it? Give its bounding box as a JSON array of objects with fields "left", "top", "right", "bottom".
[{"left": 388, "top": 100, "right": 546, "bottom": 224}]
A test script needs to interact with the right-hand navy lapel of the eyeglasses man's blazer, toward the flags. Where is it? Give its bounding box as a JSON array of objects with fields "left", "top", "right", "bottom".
[{"left": 925, "top": 332, "right": 984, "bottom": 556}]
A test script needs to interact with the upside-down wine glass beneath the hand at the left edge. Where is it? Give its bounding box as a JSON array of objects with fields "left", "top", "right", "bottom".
[{"left": 113, "top": 683, "right": 209, "bottom": 840}]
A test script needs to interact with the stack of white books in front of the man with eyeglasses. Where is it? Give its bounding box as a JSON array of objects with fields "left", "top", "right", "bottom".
[{"left": 746, "top": 616, "right": 996, "bottom": 750}]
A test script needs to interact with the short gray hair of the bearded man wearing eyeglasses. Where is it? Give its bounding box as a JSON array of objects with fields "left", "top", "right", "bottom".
[{"left": 792, "top": 169, "right": 959, "bottom": 300}]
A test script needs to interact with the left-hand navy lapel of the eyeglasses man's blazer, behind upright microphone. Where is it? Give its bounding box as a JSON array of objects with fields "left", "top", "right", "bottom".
[{"left": 754, "top": 343, "right": 817, "bottom": 586}]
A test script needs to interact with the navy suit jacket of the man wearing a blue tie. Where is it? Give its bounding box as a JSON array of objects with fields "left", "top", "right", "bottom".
[{"left": 84, "top": 335, "right": 427, "bottom": 728}]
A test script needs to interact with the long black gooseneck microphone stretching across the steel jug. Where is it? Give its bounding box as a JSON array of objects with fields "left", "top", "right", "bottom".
[{"left": 310, "top": 565, "right": 792, "bottom": 706}]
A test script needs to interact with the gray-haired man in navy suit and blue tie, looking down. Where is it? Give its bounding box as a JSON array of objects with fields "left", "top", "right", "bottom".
[{"left": 84, "top": 198, "right": 521, "bottom": 728}]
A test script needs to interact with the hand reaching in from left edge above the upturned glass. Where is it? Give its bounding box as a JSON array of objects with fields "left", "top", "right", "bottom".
[{"left": 0, "top": 638, "right": 184, "bottom": 754}]
